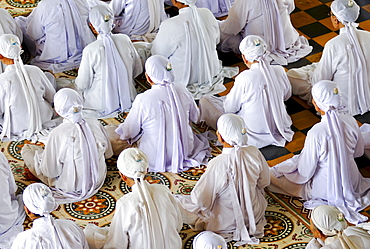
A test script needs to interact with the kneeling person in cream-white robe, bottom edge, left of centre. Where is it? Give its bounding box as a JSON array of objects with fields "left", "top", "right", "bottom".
[{"left": 84, "top": 148, "right": 182, "bottom": 249}]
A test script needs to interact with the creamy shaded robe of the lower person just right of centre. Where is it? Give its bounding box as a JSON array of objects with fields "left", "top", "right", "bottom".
[{"left": 176, "top": 146, "right": 270, "bottom": 244}]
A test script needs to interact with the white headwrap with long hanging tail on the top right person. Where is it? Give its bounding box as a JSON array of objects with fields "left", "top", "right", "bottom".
[{"left": 331, "top": 0, "right": 370, "bottom": 114}]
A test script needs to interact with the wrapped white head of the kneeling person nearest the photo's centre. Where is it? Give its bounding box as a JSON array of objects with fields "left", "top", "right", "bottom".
[{"left": 145, "top": 55, "right": 175, "bottom": 84}]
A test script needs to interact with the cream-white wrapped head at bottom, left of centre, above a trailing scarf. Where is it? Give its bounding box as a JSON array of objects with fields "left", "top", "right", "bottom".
[{"left": 117, "top": 148, "right": 149, "bottom": 179}]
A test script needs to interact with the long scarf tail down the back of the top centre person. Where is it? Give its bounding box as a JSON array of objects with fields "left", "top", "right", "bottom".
[{"left": 178, "top": 0, "right": 213, "bottom": 86}]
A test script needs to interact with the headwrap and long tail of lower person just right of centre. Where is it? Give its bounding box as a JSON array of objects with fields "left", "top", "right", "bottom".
[{"left": 217, "top": 113, "right": 259, "bottom": 246}]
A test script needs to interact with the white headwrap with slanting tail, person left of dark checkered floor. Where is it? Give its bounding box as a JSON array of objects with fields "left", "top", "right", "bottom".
[{"left": 239, "top": 35, "right": 291, "bottom": 144}]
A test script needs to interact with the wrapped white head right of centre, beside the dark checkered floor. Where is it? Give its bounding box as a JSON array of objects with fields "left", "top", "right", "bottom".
[{"left": 239, "top": 35, "right": 267, "bottom": 62}]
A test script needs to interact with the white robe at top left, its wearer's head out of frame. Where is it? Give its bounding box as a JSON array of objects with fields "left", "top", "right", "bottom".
[{"left": 17, "top": 0, "right": 95, "bottom": 73}]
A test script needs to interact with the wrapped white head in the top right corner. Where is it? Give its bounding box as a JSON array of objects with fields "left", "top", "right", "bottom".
[{"left": 331, "top": 0, "right": 360, "bottom": 25}]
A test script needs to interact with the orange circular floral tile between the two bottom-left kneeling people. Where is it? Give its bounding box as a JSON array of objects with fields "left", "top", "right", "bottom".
[{"left": 65, "top": 191, "right": 116, "bottom": 220}]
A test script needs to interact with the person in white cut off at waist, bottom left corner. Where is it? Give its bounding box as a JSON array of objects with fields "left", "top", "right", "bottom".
[{"left": 12, "top": 183, "right": 89, "bottom": 249}]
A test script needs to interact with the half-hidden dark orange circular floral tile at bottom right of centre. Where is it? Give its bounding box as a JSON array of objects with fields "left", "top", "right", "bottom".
[{"left": 260, "top": 211, "right": 293, "bottom": 242}]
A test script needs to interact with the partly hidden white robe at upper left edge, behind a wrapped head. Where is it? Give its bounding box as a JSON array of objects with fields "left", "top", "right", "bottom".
[{"left": 0, "top": 9, "right": 23, "bottom": 73}]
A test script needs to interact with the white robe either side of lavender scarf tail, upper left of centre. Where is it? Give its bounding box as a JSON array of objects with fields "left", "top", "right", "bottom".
[{"left": 75, "top": 34, "right": 143, "bottom": 117}]
